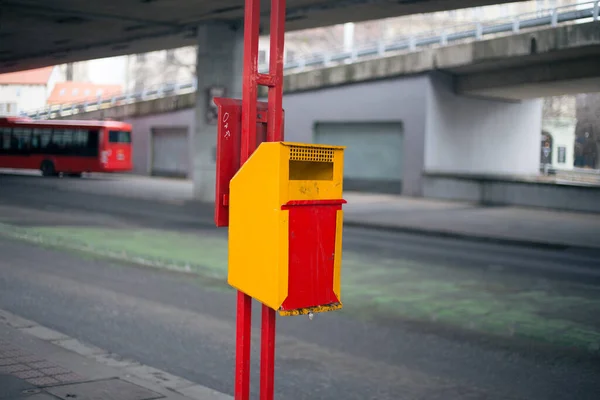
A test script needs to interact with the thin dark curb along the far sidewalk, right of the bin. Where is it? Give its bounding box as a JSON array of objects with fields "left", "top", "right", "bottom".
[{"left": 344, "top": 219, "right": 600, "bottom": 251}]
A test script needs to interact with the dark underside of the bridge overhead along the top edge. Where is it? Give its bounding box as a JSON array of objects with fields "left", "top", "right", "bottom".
[{"left": 0, "top": 0, "right": 514, "bottom": 73}]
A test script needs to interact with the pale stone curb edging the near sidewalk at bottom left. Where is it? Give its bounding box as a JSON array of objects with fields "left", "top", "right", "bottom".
[{"left": 0, "top": 309, "right": 233, "bottom": 400}]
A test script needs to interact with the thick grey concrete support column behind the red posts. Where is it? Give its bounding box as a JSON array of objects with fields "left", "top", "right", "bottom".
[{"left": 191, "top": 23, "right": 244, "bottom": 202}]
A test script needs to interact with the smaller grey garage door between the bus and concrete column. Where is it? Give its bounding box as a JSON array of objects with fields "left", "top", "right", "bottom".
[{"left": 152, "top": 127, "right": 189, "bottom": 178}]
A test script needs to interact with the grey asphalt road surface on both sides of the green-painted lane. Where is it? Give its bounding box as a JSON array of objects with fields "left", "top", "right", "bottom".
[{"left": 0, "top": 175, "right": 600, "bottom": 400}]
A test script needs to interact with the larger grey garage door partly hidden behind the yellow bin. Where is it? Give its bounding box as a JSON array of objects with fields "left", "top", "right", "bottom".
[{"left": 315, "top": 122, "right": 403, "bottom": 193}]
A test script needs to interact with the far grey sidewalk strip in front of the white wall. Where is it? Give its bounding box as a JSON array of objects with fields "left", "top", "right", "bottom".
[{"left": 344, "top": 192, "right": 600, "bottom": 249}]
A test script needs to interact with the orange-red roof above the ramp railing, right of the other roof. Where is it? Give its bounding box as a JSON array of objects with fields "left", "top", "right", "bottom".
[{"left": 47, "top": 81, "right": 123, "bottom": 104}]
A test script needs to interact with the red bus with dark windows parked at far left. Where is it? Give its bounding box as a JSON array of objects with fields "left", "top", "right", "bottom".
[{"left": 0, "top": 117, "right": 132, "bottom": 176}]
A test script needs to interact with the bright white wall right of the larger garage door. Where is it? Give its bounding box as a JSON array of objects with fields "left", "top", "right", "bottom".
[{"left": 425, "top": 74, "right": 542, "bottom": 175}]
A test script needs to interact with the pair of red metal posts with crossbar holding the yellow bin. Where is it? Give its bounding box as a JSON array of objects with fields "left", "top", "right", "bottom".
[{"left": 235, "top": 0, "right": 285, "bottom": 400}]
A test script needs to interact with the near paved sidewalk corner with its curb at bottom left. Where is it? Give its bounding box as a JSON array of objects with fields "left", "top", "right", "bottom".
[{"left": 0, "top": 310, "right": 232, "bottom": 400}]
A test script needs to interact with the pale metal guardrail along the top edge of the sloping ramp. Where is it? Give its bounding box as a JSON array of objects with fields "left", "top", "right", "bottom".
[{"left": 21, "top": 0, "right": 600, "bottom": 119}]
